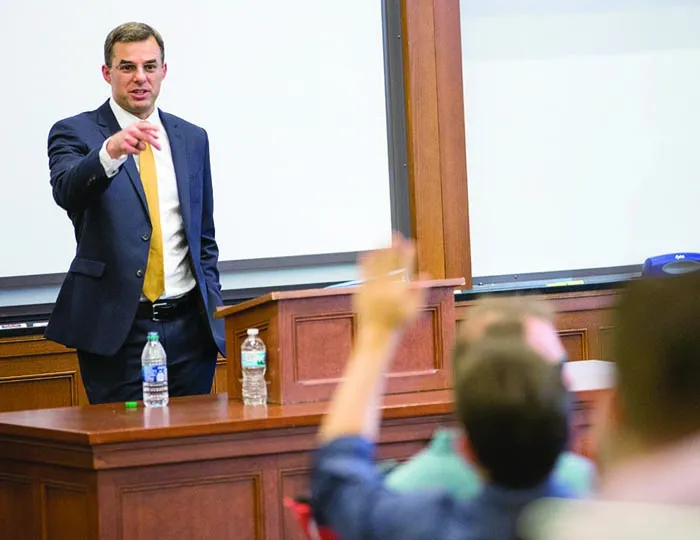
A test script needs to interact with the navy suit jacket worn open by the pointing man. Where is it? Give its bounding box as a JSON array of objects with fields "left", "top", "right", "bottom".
[{"left": 45, "top": 101, "right": 225, "bottom": 356}]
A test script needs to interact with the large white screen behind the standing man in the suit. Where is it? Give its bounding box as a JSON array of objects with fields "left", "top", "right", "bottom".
[{"left": 0, "top": 0, "right": 391, "bottom": 277}]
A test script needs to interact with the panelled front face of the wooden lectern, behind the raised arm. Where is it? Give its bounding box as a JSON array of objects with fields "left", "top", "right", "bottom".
[{"left": 278, "top": 288, "right": 454, "bottom": 403}]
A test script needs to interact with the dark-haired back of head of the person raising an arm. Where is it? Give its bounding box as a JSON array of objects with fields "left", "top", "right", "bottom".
[{"left": 455, "top": 336, "right": 569, "bottom": 489}]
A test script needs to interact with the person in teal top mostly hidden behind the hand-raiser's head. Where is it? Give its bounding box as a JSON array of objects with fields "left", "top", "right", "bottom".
[{"left": 386, "top": 297, "right": 596, "bottom": 499}]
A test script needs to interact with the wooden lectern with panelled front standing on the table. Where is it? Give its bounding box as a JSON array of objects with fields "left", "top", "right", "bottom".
[{"left": 216, "top": 278, "right": 464, "bottom": 404}]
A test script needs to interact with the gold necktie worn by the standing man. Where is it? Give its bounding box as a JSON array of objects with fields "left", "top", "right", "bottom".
[{"left": 139, "top": 143, "right": 165, "bottom": 302}]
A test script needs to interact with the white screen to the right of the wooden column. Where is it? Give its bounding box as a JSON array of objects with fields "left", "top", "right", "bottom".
[{"left": 461, "top": 0, "right": 700, "bottom": 276}]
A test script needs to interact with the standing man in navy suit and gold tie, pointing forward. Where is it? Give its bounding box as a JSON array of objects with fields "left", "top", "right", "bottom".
[{"left": 46, "top": 23, "right": 224, "bottom": 403}]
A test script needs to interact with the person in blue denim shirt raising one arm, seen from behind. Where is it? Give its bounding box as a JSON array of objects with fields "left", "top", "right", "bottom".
[{"left": 311, "top": 238, "right": 571, "bottom": 540}]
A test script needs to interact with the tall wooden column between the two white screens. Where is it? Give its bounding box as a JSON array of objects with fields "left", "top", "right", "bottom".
[{"left": 401, "top": 0, "right": 471, "bottom": 287}]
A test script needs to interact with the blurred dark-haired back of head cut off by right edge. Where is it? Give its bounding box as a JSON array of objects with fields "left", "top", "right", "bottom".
[{"left": 613, "top": 272, "right": 700, "bottom": 443}]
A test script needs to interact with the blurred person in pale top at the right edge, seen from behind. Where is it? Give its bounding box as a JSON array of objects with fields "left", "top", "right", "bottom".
[{"left": 523, "top": 272, "right": 700, "bottom": 540}]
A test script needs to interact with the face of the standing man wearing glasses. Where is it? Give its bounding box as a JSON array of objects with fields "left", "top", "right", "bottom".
[{"left": 102, "top": 36, "right": 168, "bottom": 119}]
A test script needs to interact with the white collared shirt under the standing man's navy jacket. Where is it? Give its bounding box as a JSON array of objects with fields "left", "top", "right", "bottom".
[{"left": 100, "top": 98, "right": 196, "bottom": 299}]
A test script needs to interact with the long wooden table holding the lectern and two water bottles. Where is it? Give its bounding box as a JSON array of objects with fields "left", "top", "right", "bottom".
[{"left": 0, "top": 391, "right": 452, "bottom": 540}]
